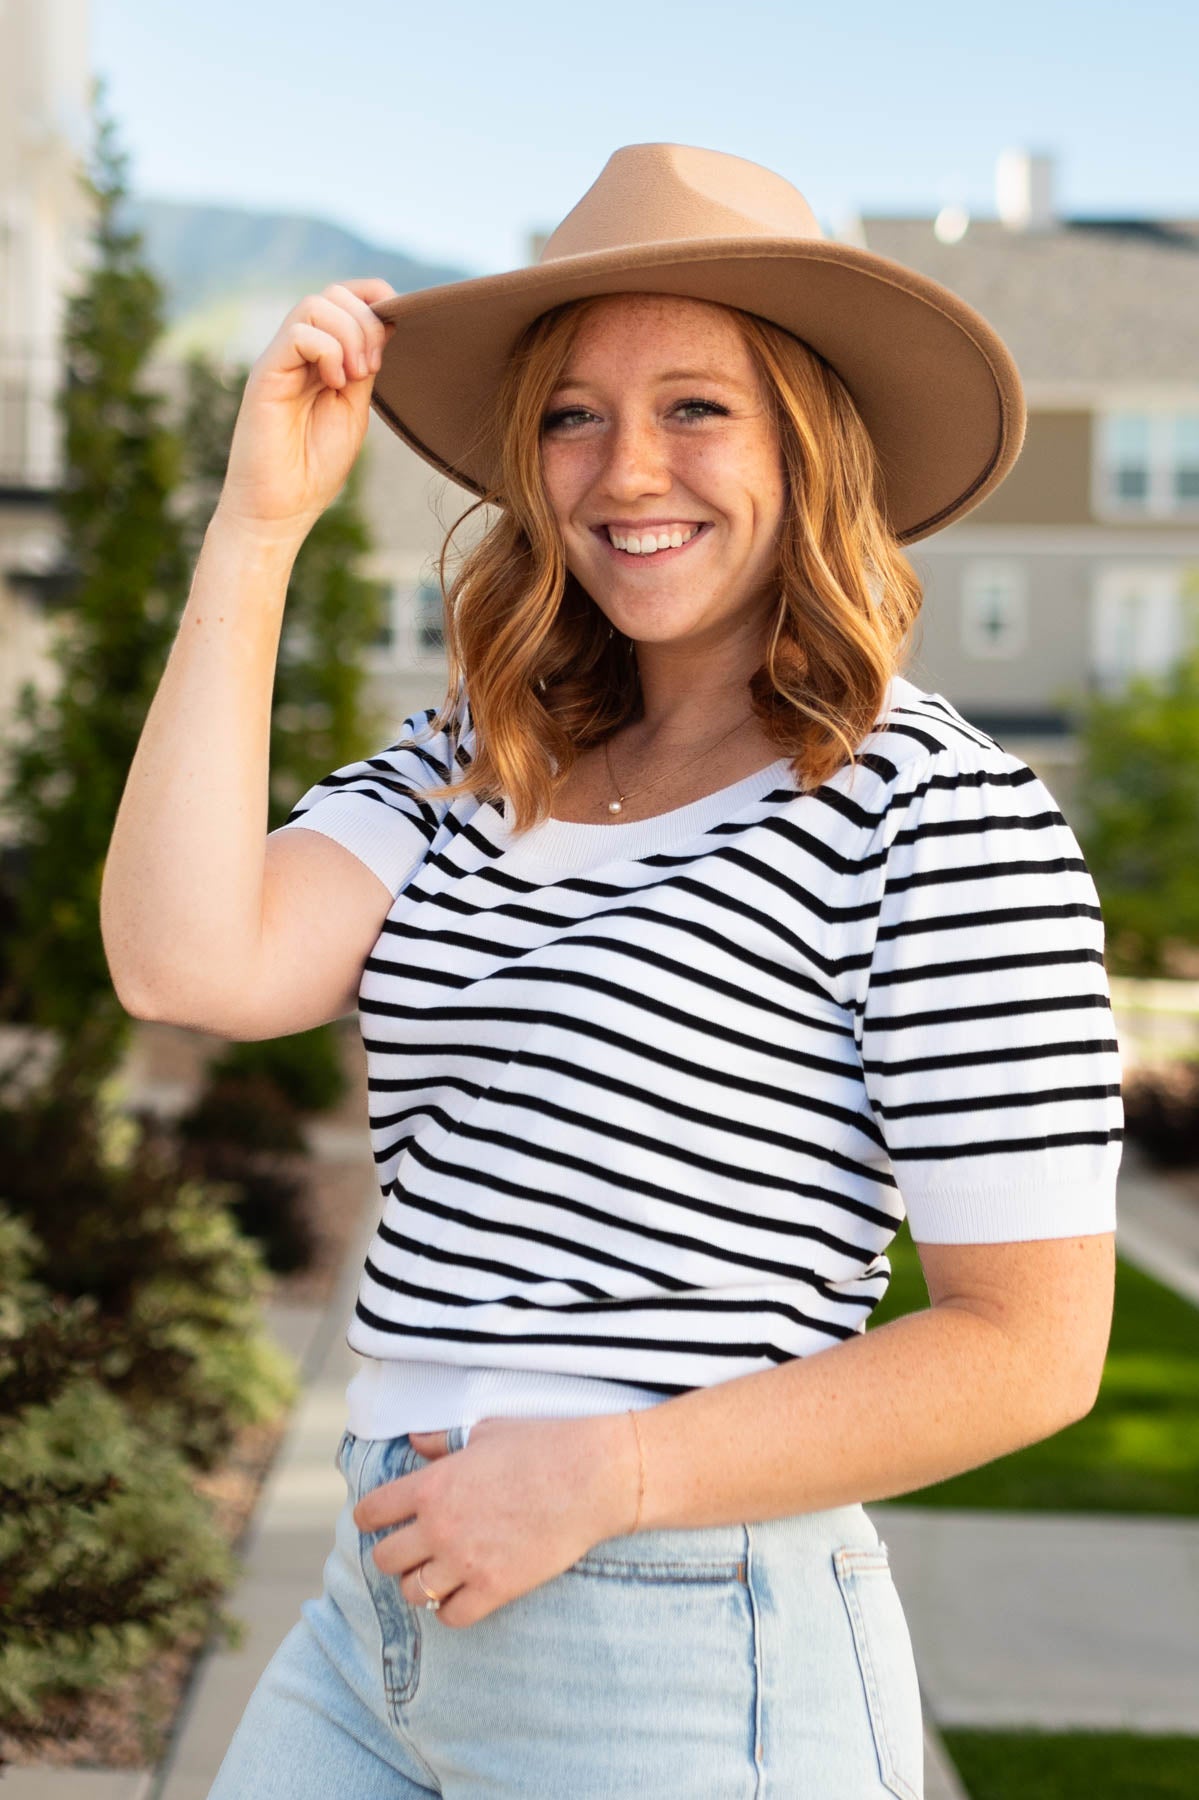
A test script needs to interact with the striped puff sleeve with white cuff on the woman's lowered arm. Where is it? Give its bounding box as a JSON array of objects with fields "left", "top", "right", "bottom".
[{"left": 855, "top": 743, "right": 1123, "bottom": 1244}]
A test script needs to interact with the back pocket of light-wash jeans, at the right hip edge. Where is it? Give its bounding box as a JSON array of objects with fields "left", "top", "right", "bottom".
[{"left": 834, "top": 1544, "right": 924, "bottom": 1800}]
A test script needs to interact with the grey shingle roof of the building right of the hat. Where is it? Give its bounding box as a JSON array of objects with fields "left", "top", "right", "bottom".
[{"left": 837, "top": 214, "right": 1199, "bottom": 383}]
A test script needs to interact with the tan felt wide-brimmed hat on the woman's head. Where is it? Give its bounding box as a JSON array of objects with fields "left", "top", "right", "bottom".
[{"left": 371, "top": 144, "right": 1026, "bottom": 544}]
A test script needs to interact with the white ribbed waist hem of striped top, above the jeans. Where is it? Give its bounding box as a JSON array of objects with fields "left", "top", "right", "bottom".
[{"left": 346, "top": 1357, "right": 666, "bottom": 1438}]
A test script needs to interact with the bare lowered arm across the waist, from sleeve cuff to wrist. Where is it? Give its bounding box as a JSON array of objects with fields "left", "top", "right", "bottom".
[{"left": 583, "top": 1231, "right": 1116, "bottom": 1532}]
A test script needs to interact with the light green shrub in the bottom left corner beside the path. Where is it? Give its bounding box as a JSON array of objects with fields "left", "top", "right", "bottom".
[{"left": 0, "top": 1208, "right": 243, "bottom": 1768}]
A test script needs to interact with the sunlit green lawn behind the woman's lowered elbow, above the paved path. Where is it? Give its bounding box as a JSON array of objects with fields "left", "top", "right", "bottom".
[{"left": 866, "top": 1220, "right": 1199, "bottom": 1519}]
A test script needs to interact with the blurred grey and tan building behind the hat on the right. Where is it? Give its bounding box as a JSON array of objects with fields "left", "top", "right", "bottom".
[{"left": 839, "top": 151, "right": 1199, "bottom": 808}]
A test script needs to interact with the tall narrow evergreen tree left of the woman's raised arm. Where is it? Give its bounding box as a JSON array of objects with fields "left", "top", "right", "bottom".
[{"left": 0, "top": 83, "right": 187, "bottom": 1080}]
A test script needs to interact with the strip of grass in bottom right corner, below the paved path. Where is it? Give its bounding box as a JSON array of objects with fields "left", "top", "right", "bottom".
[{"left": 942, "top": 1732, "right": 1199, "bottom": 1800}]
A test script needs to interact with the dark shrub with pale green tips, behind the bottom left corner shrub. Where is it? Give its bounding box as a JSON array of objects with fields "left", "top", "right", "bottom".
[{"left": 0, "top": 1064, "right": 295, "bottom": 1469}]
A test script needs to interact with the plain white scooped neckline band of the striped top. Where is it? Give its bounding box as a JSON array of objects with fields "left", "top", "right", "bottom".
[{"left": 482, "top": 756, "right": 799, "bottom": 869}]
